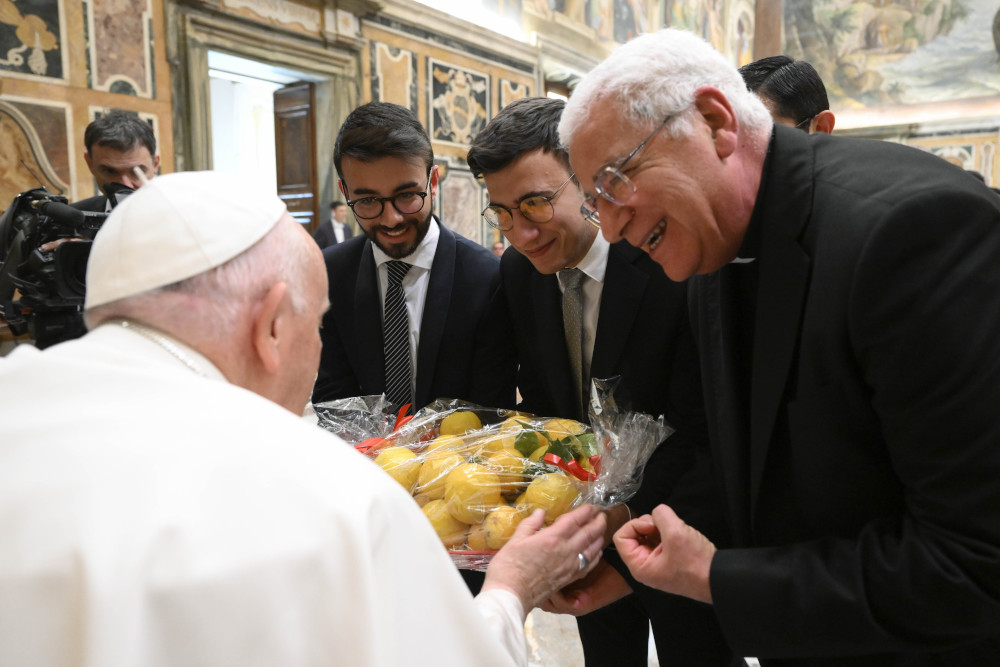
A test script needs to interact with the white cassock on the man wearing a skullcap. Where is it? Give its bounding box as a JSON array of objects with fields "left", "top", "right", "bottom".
[{"left": 0, "top": 324, "right": 527, "bottom": 667}]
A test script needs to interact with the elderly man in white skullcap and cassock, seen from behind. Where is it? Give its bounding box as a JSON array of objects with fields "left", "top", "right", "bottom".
[{"left": 0, "top": 172, "right": 605, "bottom": 667}]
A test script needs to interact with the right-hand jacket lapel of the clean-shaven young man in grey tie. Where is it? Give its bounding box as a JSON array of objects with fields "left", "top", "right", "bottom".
[{"left": 586, "top": 241, "right": 649, "bottom": 383}]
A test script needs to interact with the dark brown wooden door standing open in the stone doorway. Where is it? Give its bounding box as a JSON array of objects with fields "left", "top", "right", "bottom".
[{"left": 274, "top": 81, "right": 319, "bottom": 232}]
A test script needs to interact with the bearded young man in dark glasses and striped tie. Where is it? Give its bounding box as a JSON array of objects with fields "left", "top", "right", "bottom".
[{"left": 313, "top": 102, "right": 516, "bottom": 418}]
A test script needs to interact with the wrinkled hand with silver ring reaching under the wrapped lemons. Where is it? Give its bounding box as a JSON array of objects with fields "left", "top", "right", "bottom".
[{"left": 483, "top": 505, "right": 607, "bottom": 612}]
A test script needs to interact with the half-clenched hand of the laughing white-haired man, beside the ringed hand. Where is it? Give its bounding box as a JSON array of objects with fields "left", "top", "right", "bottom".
[{"left": 615, "top": 505, "right": 716, "bottom": 604}]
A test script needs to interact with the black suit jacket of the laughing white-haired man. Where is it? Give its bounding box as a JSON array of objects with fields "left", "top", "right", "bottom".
[{"left": 691, "top": 126, "right": 1000, "bottom": 667}]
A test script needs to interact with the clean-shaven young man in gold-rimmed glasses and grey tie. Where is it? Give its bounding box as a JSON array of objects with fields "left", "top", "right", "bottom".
[{"left": 468, "top": 98, "right": 729, "bottom": 667}]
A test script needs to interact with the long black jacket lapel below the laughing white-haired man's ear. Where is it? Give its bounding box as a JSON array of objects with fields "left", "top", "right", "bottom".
[{"left": 750, "top": 128, "right": 813, "bottom": 511}]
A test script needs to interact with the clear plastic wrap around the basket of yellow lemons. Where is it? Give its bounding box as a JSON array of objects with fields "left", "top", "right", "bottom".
[{"left": 315, "top": 381, "right": 673, "bottom": 570}]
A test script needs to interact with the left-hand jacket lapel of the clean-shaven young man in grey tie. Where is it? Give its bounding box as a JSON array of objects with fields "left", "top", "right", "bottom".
[{"left": 531, "top": 269, "right": 582, "bottom": 419}]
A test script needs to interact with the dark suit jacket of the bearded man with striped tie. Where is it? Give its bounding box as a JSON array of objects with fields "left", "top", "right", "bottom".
[{"left": 313, "top": 225, "right": 516, "bottom": 409}]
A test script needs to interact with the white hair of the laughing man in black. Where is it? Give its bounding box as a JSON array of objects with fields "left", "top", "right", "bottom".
[{"left": 559, "top": 28, "right": 772, "bottom": 146}]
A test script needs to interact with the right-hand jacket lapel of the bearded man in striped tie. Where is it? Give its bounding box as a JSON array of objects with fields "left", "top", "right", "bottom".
[{"left": 413, "top": 222, "right": 456, "bottom": 407}]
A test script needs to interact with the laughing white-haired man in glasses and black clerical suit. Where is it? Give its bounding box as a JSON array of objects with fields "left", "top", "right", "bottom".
[{"left": 560, "top": 30, "right": 1000, "bottom": 667}]
